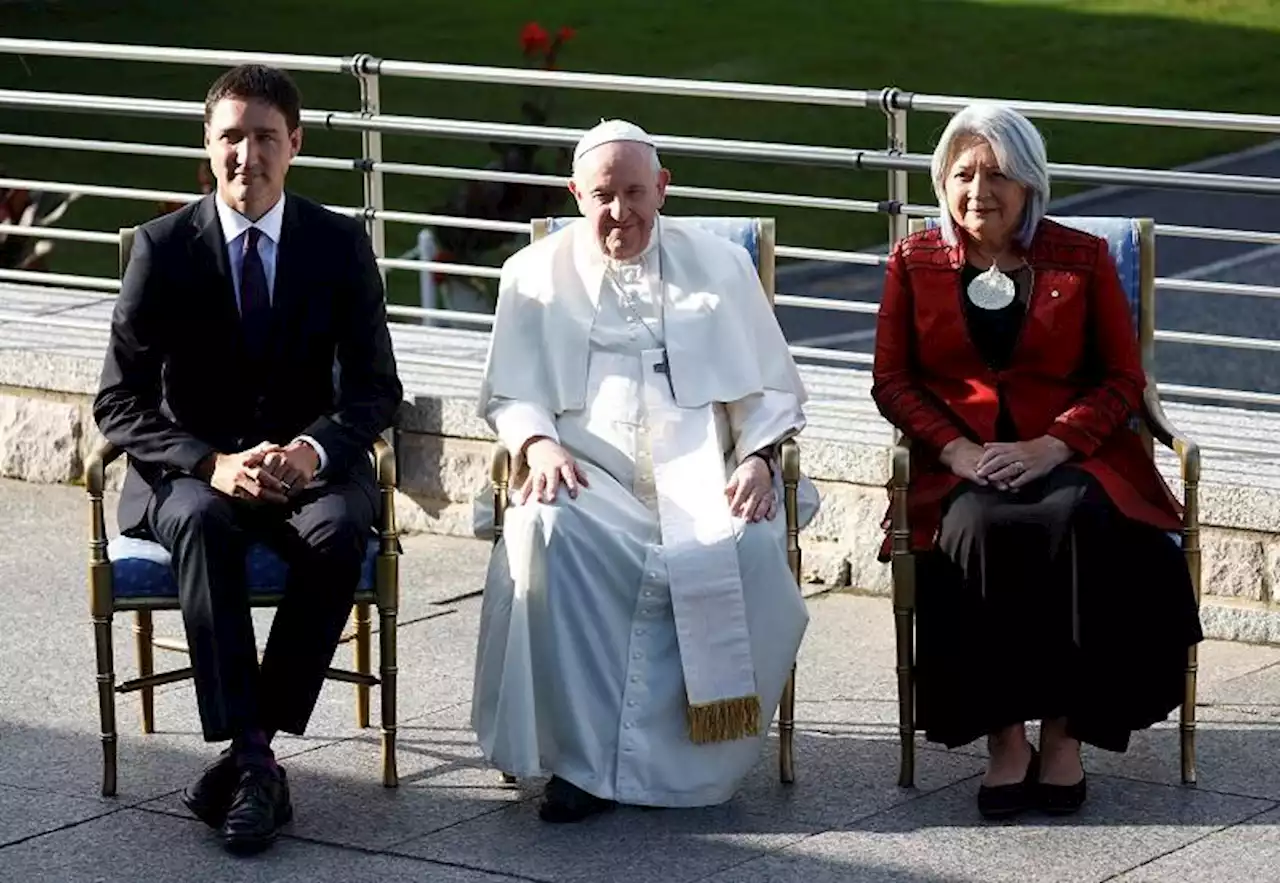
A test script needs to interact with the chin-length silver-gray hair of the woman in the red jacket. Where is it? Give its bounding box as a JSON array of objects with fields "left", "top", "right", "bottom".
[{"left": 932, "top": 102, "right": 1048, "bottom": 248}]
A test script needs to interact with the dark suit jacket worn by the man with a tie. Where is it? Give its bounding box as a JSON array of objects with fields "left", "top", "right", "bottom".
[{"left": 93, "top": 193, "right": 402, "bottom": 531}]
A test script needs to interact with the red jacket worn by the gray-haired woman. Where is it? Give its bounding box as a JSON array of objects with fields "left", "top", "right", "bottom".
[{"left": 872, "top": 219, "right": 1181, "bottom": 552}]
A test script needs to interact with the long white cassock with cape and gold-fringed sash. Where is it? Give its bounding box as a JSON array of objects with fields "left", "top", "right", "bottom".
[{"left": 472, "top": 218, "right": 817, "bottom": 806}]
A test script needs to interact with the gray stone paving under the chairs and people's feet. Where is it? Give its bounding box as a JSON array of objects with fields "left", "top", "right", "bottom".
[{"left": 0, "top": 480, "right": 1280, "bottom": 883}]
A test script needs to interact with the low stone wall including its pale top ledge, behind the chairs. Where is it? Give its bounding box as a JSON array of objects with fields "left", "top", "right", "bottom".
[{"left": 0, "top": 283, "right": 1280, "bottom": 645}]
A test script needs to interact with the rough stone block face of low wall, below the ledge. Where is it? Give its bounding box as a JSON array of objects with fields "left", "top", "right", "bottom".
[{"left": 0, "top": 356, "right": 1280, "bottom": 645}]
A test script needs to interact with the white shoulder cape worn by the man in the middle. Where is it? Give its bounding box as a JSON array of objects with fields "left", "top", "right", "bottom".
[{"left": 479, "top": 216, "right": 808, "bottom": 417}]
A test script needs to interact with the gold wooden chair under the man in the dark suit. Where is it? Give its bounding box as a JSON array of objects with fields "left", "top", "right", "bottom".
[{"left": 84, "top": 228, "right": 399, "bottom": 797}]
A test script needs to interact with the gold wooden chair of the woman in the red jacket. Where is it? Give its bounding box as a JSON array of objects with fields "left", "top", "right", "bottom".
[{"left": 890, "top": 218, "right": 1201, "bottom": 787}]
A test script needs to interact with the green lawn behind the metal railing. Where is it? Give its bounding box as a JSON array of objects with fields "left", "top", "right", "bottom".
[{"left": 0, "top": 0, "right": 1280, "bottom": 299}]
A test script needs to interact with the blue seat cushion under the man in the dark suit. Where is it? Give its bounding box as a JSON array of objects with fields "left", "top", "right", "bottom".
[{"left": 106, "top": 536, "right": 379, "bottom": 599}]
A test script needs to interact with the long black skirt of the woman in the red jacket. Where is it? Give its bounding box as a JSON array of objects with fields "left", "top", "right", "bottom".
[{"left": 916, "top": 466, "right": 1203, "bottom": 751}]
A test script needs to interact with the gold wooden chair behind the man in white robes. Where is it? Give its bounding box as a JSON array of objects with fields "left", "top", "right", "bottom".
[{"left": 489, "top": 218, "right": 800, "bottom": 783}]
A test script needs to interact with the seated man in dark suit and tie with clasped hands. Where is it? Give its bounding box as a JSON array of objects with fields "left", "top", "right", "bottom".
[{"left": 93, "top": 65, "right": 402, "bottom": 852}]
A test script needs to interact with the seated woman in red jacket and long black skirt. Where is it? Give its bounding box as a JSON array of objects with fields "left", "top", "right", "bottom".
[{"left": 872, "top": 105, "right": 1202, "bottom": 816}]
